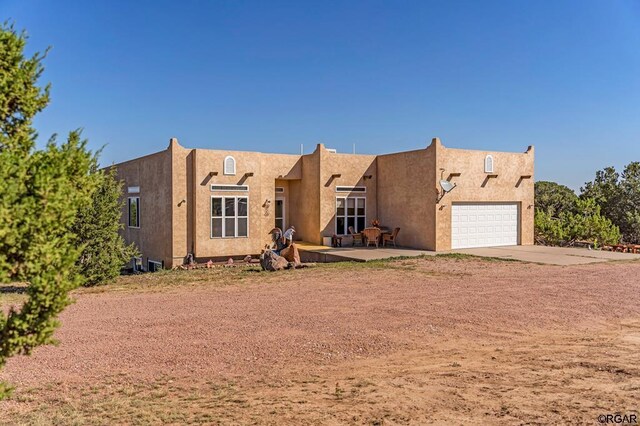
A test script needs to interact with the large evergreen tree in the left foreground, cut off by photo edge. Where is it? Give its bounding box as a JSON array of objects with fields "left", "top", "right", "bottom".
[{"left": 0, "top": 24, "right": 96, "bottom": 398}]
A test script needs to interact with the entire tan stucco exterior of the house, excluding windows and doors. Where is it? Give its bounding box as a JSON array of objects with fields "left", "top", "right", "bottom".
[{"left": 114, "top": 138, "right": 534, "bottom": 268}]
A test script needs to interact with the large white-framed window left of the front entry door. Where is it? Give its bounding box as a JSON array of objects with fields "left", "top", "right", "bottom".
[{"left": 211, "top": 196, "right": 249, "bottom": 238}]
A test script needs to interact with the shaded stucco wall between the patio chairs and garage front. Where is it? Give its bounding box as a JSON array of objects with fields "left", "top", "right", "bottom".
[{"left": 377, "top": 146, "right": 436, "bottom": 250}]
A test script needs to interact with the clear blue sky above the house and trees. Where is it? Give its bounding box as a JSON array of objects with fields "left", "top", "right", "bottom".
[{"left": 5, "top": 0, "right": 640, "bottom": 189}]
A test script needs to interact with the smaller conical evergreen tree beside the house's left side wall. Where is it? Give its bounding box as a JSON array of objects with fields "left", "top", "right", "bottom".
[{"left": 73, "top": 168, "right": 138, "bottom": 286}]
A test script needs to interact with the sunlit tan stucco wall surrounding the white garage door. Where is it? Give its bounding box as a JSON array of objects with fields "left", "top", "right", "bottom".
[{"left": 434, "top": 143, "right": 534, "bottom": 251}]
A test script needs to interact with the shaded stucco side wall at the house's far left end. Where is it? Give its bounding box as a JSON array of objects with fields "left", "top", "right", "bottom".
[{"left": 113, "top": 151, "right": 173, "bottom": 268}]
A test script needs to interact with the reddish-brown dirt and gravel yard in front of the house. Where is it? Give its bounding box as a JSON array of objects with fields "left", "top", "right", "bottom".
[{"left": 0, "top": 255, "right": 640, "bottom": 425}]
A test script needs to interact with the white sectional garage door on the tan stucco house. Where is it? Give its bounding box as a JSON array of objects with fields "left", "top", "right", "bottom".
[{"left": 451, "top": 203, "right": 518, "bottom": 249}]
